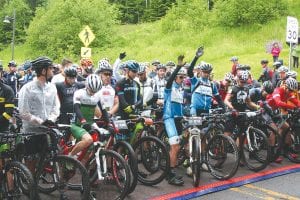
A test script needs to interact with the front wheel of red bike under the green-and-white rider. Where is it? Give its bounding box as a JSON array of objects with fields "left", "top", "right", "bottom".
[{"left": 86, "top": 149, "right": 131, "bottom": 200}]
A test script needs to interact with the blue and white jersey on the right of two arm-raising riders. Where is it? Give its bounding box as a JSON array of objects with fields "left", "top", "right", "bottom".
[{"left": 191, "top": 77, "right": 219, "bottom": 115}]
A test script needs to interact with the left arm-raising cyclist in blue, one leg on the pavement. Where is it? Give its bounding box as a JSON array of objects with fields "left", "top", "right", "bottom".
[{"left": 163, "top": 56, "right": 186, "bottom": 186}]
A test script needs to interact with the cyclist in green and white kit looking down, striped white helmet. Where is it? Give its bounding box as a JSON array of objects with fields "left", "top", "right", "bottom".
[{"left": 70, "top": 74, "right": 107, "bottom": 156}]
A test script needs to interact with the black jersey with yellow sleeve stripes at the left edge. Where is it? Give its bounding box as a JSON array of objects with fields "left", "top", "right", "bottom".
[{"left": 0, "top": 81, "right": 14, "bottom": 131}]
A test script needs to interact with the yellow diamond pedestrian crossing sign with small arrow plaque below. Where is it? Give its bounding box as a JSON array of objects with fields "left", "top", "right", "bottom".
[{"left": 78, "top": 26, "right": 95, "bottom": 58}]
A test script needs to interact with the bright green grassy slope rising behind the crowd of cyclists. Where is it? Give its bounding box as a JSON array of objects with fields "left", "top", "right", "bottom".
[{"left": 0, "top": 0, "right": 300, "bottom": 79}]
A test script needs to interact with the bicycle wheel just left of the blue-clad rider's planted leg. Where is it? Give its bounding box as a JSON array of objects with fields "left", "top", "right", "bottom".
[{"left": 133, "top": 136, "right": 170, "bottom": 185}]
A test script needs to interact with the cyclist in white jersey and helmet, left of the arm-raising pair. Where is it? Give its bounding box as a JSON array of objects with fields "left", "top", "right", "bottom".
[{"left": 138, "top": 63, "right": 154, "bottom": 108}]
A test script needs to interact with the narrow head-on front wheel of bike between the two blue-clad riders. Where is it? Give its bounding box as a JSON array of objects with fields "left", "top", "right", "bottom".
[{"left": 191, "top": 137, "right": 201, "bottom": 187}]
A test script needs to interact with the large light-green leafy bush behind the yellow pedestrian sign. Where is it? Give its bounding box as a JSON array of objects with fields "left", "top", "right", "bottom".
[{"left": 26, "top": 0, "right": 118, "bottom": 60}]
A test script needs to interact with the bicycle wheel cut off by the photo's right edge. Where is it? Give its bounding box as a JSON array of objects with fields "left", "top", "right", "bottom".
[{"left": 282, "top": 129, "right": 300, "bottom": 163}]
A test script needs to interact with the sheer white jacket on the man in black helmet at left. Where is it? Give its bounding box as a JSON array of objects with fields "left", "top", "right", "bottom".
[{"left": 18, "top": 79, "right": 60, "bottom": 132}]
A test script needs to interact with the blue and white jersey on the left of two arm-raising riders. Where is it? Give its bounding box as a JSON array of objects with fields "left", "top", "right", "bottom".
[{"left": 163, "top": 82, "right": 184, "bottom": 119}]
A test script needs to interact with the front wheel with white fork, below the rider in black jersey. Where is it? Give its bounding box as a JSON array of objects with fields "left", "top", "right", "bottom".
[{"left": 240, "top": 127, "right": 271, "bottom": 171}]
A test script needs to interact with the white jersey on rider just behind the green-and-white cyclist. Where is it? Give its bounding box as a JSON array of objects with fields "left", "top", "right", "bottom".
[{"left": 99, "top": 85, "right": 117, "bottom": 111}]
